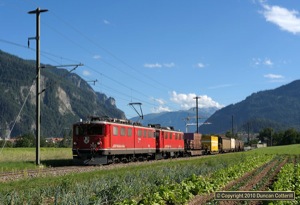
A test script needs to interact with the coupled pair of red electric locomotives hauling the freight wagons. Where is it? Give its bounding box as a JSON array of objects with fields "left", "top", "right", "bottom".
[{"left": 73, "top": 117, "right": 184, "bottom": 165}]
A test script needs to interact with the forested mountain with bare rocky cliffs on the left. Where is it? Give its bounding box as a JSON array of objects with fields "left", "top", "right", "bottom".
[{"left": 0, "top": 50, "right": 125, "bottom": 137}]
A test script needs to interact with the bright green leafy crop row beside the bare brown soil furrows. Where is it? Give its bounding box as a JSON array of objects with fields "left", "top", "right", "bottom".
[{"left": 117, "top": 156, "right": 272, "bottom": 205}]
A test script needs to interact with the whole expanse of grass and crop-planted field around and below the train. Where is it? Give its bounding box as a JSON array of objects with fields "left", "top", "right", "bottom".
[{"left": 0, "top": 145, "right": 300, "bottom": 205}]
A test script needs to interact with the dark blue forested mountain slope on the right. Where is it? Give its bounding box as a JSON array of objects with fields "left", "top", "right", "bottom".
[{"left": 199, "top": 80, "right": 300, "bottom": 133}]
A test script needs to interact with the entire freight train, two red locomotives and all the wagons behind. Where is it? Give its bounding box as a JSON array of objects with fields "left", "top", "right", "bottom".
[{"left": 72, "top": 117, "right": 244, "bottom": 165}]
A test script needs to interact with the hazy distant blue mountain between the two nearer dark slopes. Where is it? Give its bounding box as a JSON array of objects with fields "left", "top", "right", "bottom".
[{"left": 130, "top": 107, "right": 218, "bottom": 132}]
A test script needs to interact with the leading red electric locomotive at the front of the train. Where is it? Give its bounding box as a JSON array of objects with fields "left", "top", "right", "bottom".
[{"left": 73, "top": 117, "right": 156, "bottom": 165}]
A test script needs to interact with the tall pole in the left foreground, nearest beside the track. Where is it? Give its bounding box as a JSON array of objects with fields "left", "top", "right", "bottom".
[{"left": 28, "top": 8, "right": 48, "bottom": 165}]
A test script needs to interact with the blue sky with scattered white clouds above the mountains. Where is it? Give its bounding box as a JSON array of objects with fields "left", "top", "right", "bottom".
[{"left": 0, "top": 0, "right": 300, "bottom": 118}]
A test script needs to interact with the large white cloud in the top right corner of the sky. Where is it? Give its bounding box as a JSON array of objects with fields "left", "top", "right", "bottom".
[{"left": 262, "top": 3, "right": 300, "bottom": 34}]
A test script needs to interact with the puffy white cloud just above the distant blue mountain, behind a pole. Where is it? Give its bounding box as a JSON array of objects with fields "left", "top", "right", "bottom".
[{"left": 171, "top": 91, "right": 223, "bottom": 110}]
